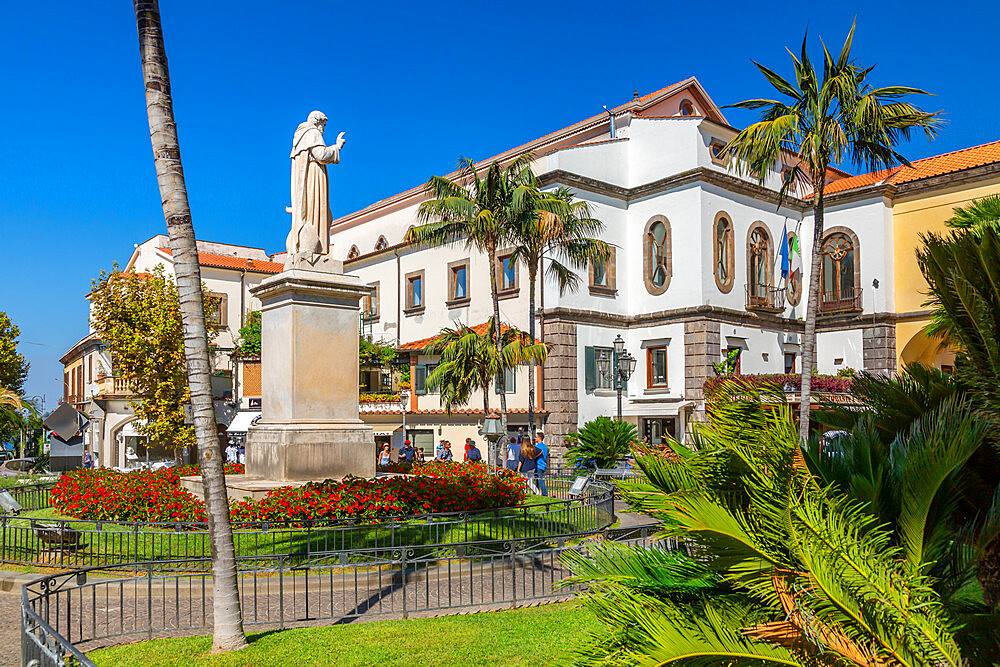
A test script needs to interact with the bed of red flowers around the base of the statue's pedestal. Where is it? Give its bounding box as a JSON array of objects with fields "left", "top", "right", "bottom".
[{"left": 52, "top": 461, "right": 526, "bottom": 523}]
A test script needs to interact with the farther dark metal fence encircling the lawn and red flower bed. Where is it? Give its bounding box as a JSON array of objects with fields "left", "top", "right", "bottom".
[{"left": 0, "top": 477, "right": 614, "bottom": 570}]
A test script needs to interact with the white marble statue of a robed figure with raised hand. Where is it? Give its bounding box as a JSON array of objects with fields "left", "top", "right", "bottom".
[{"left": 285, "top": 111, "right": 344, "bottom": 270}]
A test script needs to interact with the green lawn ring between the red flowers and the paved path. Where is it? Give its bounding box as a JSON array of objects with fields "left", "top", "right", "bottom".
[{"left": 5, "top": 495, "right": 600, "bottom": 565}]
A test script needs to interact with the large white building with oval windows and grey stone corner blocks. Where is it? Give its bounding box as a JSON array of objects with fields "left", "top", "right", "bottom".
[{"left": 331, "top": 78, "right": 895, "bottom": 454}]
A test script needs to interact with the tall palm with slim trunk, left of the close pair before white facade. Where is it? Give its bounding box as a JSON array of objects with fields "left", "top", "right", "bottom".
[{"left": 406, "top": 154, "right": 535, "bottom": 433}]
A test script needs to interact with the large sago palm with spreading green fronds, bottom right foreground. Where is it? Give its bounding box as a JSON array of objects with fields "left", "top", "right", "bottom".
[{"left": 568, "top": 382, "right": 966, "bottom": 667}]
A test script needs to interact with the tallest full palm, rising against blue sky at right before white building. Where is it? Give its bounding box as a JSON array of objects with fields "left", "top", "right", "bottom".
[{"left": 725, "top": 26, "right": 941, "bottom": 441}]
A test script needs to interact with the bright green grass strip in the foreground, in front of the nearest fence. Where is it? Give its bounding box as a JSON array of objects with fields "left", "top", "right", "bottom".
[{"left": 88, "top": 602, "right": 602, "bottom": 667}]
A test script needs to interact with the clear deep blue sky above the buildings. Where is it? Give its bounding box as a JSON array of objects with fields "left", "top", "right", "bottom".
[{"left": 0, "top": 0, "right": 1000, "bottom": 408}]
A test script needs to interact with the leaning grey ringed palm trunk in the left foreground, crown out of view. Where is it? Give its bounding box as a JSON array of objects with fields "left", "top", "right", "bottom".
[{"left": 134, "top": 0, "right": 247, "bottom": 653}]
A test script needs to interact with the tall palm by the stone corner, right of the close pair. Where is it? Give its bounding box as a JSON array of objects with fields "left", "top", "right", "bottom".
[{"left": 512, "top": 185, "right": 611, "bottom": 440}]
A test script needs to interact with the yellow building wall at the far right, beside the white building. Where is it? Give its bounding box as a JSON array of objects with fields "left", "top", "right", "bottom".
[{"left": 892, "top": 177, "right": 1000, "bottom": 367}]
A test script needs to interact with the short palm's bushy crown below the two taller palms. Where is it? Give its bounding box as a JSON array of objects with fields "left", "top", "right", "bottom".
[{"left": 424, "top": 319, "right": 547, "bottom": 415}]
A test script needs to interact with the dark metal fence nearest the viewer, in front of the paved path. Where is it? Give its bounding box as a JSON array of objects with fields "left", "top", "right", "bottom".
[{"left": 22, "top": 529, "right": 668, "bottom": 665}]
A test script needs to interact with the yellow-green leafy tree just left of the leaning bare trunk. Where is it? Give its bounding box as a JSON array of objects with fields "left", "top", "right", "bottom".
[{"left": 90, "top": 265, "right": 215, "bottom": 450}]
